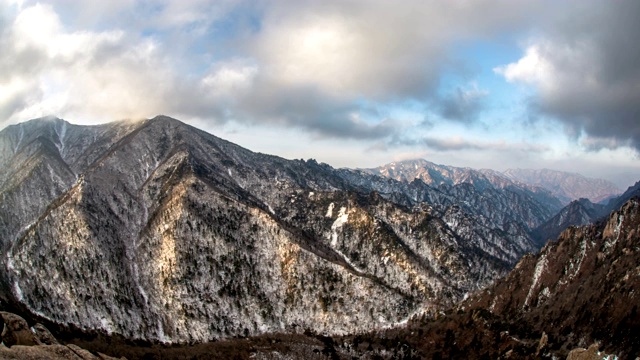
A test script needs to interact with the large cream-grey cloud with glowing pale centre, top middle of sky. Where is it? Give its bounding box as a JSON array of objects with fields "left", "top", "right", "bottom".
[{"left": 247, "top": 0, "right": 533, "bottom": 101}]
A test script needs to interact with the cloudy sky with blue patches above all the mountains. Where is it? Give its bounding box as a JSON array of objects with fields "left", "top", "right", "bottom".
[{"left": 0, "top": 0, "right": 640, "bottom": 189}]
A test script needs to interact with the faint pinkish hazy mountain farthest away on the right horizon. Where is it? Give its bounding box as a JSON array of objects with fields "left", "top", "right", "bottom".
[{"left": 504, "top": 169, "right": 622, "bottom": 203}]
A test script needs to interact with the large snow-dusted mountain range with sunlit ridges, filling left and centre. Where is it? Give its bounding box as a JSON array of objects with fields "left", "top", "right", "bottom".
[{"left": 0, "top": 116, "right": 561, "bottom": 343}]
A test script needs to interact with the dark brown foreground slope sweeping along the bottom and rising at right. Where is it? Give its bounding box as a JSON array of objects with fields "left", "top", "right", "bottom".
[{"left": 61, "top": 198, "right": 640, "bottom": 359}]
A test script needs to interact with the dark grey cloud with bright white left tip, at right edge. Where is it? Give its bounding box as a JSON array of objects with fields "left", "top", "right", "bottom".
[{"left": 495, "top": 1, "right": 640, "bottom": 150}]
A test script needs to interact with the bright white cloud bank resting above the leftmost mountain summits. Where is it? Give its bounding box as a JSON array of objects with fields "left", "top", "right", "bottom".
[{"left": 0, "top": 4, "right": 172, "bottom": 123}]
